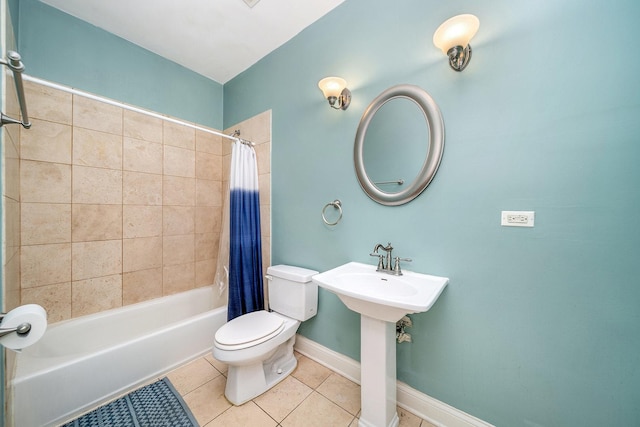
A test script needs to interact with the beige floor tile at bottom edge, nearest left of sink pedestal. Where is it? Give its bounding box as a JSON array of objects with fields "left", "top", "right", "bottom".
[{"left": 280, "top": 391, "right": 354, "bottom": 427}]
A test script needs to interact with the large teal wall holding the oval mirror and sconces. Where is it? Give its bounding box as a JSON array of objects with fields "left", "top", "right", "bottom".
[{"left": 224, "top": 0, "right": 640, "bottom": 427}]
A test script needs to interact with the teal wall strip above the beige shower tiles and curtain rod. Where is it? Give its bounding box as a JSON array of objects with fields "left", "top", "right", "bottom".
[{"left": 18, "top": 0, "right": 223, "bottom": 129}]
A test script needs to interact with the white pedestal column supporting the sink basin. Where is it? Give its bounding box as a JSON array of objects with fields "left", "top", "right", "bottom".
[{"left": 358, "top": 315, "right": 400, "bottom": 427}]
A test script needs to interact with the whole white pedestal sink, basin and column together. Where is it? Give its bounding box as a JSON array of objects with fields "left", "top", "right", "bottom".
[{"left": 313, "top": 262, "right": 449, "bottom": 427}]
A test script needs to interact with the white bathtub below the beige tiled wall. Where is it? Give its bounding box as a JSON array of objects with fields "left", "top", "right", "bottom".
[{"left": 11, "top": 287, "right": 227, "bottom": 427}]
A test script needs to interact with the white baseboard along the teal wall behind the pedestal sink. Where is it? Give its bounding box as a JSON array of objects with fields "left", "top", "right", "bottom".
[{"left": 295, "top": 335, "right": 494, "bottom": 427}]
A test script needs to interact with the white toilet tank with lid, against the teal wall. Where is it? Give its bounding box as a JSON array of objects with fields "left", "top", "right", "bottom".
[{"left": 267, "top": 265, "right": 318, "bottom": 321}]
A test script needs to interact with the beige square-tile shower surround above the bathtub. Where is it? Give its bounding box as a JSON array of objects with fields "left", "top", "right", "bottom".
[{"left": 15, "top": 81, "right": 271, "bottom": 322}]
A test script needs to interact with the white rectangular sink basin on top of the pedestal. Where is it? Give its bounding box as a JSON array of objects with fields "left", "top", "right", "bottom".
[{"left": 313, "top": 262, "right": 449, "bottom": 323}]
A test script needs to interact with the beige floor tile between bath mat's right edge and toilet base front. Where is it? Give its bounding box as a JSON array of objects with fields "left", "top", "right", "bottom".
[{"left": 183, "top": 375, "right": 232, "bottom": 426}]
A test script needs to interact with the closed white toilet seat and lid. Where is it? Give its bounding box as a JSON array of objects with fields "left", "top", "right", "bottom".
[{"left": 215, "top": 310, "right": 284, "bottom": 350}]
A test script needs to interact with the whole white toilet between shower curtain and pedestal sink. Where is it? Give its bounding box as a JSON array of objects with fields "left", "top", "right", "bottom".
[{"left": 213, "top": 265, "right": 318, "bottom": 405}]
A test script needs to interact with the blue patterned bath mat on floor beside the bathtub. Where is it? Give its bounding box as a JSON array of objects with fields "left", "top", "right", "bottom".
[{"left": 63, "top": 378, "right": 198, "bottom": 427}]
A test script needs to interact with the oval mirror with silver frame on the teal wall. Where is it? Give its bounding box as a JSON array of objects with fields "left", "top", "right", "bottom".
[{"left": 353, "top": 85, "right": 444, "bottom": 206}]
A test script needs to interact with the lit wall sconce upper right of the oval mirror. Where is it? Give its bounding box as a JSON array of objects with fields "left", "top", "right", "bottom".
[{"left": 433, "top": 14, "right": 480, "bottom": 71}]
